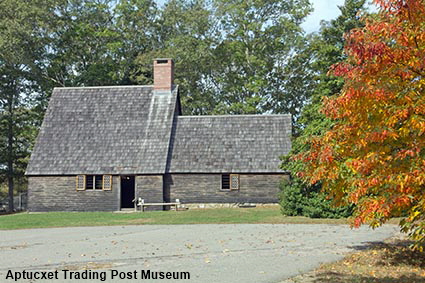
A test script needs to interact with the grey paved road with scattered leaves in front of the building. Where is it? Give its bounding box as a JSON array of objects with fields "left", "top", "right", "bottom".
[{"left": 0, "top": 224, "right": 397, "bottom": 283}]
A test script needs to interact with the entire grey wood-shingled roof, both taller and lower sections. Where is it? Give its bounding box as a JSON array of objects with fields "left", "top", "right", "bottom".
[{"left": 26, "top": 86, "right": 291, "bottom": 175}]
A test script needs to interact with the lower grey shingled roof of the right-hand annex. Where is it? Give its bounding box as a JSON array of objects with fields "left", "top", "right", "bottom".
[{"left": 167, "top": 115, "right": 292, "bottom": 173}]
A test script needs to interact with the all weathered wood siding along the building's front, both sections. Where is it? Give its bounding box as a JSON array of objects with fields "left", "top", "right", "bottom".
[{"left": 28, "top": 174, "right": 288, "bottom": 211}]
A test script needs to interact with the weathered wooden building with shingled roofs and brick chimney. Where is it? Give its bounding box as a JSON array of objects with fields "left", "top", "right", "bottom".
[{"left": 26, "top": 59, "right": 291, "bottom": 211}]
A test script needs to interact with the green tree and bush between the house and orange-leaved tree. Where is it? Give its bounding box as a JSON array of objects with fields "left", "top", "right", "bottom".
[{"left": 280, "top": 0, "right": 365, "bottom": 218}]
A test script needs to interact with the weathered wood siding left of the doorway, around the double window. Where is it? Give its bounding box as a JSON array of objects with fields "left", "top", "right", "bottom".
[{"left": 28, "top": 176, "right": 120, "bottom": 211}]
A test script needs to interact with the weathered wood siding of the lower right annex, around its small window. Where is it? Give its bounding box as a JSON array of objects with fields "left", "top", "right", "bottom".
[{"left": 164, "top": 174, "right": 288, "bottom": 203}]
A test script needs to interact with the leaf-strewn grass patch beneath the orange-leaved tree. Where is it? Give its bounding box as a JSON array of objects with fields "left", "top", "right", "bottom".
[{"left": 285, "top": 236, "right": 425, "bottom": 283}]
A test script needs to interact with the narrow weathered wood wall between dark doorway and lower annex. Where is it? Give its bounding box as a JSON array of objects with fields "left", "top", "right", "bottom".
[{"left": 135, "top": 175, "right": 164, "bottom": 210}]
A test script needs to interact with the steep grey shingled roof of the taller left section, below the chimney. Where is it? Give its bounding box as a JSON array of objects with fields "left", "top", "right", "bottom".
[{"left": 26, "top": 86, "right": 179, "bottom": 175}]
